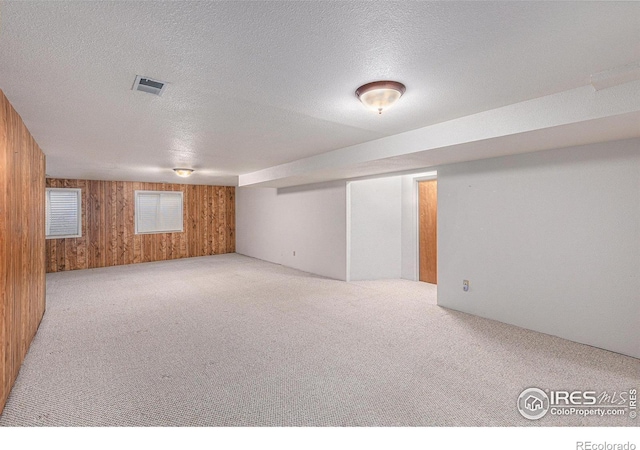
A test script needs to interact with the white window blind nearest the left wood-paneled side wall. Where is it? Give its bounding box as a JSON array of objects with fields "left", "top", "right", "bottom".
[{"left": 45, "top": 188, "right": 82, "bottom": 239}]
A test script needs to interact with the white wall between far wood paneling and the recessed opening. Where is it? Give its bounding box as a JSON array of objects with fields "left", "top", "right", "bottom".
[{"left": 236, "top": 182, "right": 347, "bottom": 280}]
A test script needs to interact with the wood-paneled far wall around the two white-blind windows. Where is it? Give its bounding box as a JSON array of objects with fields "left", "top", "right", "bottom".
[{"left": 46, "top": 178, "right": 236, "bottom": 272}]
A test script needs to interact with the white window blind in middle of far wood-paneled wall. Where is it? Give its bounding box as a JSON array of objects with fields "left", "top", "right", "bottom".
[{"left": 135, "top": 191, "right": 183, "bottom": 234}]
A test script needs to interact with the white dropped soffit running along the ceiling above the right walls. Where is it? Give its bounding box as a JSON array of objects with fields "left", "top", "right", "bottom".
[{"left": 238, "top": 81, "right": 640, "bottom": 188}]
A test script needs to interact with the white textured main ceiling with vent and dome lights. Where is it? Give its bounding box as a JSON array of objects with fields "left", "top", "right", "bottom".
[{"left": 0, "top": 1, "right": 640, "bottom": 184}]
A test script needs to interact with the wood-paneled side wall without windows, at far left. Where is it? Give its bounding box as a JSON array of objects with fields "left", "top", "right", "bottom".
[{"left": 0, "top": 91, "right": 45, "bottom": 413}]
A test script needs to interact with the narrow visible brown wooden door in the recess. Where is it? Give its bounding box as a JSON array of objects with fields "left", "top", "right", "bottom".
[{"left": 418, "top": 180, "right": 438, "bottom": 284}]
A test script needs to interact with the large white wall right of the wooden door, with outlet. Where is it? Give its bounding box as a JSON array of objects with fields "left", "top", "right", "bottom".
[{"left": 438, "top": 139, "right": 640, "bottom": 358}]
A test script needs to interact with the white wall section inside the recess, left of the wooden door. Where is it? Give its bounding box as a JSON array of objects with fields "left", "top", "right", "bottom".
[{"left": 348, "top": 176, "right": 402, "bottom": 281}]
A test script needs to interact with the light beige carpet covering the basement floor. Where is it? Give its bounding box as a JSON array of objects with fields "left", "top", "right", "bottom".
[{"left": 0, "top": 254, "right": 640, "bottom": 426}]
